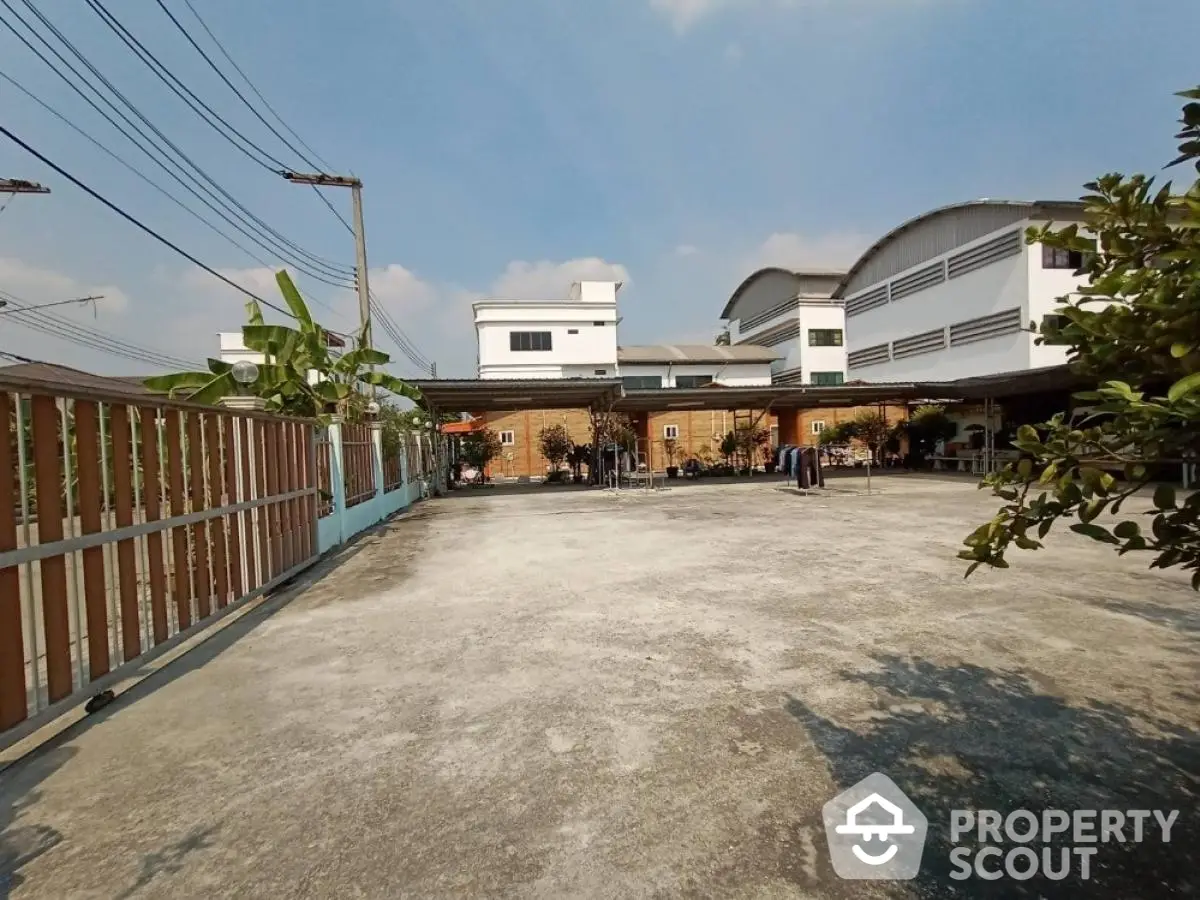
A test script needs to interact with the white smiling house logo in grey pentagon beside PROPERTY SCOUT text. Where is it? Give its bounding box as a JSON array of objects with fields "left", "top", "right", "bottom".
[{"left": 822, "top": 772, "right": 929, "bottom": 881}]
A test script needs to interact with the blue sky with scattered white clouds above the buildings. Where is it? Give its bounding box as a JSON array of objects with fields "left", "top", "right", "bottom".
[{"left": 0, "top": 0, "right": 1200, "bottom": 376}]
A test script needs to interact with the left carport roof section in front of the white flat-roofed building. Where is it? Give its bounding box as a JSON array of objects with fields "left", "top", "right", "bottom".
[{"left": 410, "top": 378, "right": 620, "bottom": 413}]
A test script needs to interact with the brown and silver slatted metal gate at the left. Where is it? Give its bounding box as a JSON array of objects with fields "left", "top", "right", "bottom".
[{"left": 0, "top": 376, "right": 318, "bottom": 745}]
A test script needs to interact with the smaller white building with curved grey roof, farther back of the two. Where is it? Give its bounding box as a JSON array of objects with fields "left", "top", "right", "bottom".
[{"left": 721, "top": 268, "right": 846, "bottom": 385}]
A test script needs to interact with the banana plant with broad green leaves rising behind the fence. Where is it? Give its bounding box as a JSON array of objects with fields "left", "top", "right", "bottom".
[{"left": 145, "top": 271, "right": 421, "bottom": 421}]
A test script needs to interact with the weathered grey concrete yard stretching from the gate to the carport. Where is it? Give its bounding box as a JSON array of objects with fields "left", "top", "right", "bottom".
[{"left": 0, "top": 476, "right": 1200, "bottom": 900}]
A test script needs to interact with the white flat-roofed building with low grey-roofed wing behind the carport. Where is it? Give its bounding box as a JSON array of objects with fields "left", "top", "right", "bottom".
[{"left": 473, "top": 281, "right": 779, "bottom": 390}]
